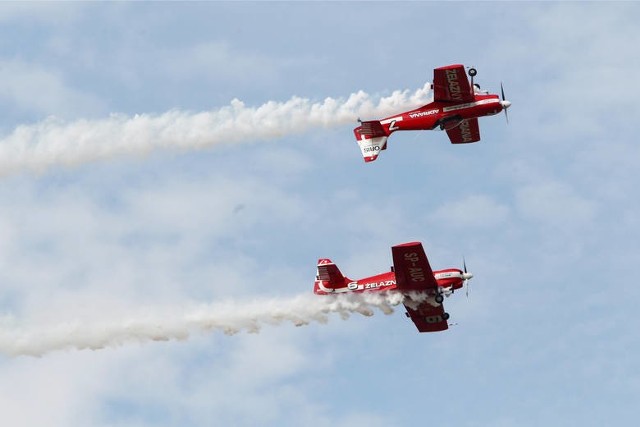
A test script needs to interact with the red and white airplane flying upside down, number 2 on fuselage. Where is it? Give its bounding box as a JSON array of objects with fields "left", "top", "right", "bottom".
[{"left": 353, "top": 64, "right": 511, "bottom": 162}]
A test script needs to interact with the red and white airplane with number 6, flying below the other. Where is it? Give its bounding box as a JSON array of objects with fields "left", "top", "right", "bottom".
[{"left": 313, "top": 242, "right": 473, "bottom": 332}]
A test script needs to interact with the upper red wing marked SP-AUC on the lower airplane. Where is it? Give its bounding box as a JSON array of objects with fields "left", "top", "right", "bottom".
[{"left": 391, "top": 242, "right": 438, "bottom": 292}]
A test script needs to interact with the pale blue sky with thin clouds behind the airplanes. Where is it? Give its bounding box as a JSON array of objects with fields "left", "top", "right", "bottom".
[{"left": 0, "top": 2, "right": 640, "bottom": 427}]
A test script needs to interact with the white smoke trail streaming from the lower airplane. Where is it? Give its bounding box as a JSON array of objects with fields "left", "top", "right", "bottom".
[{"left": 0, "top": 292, "right": 425, "bottom": 356}]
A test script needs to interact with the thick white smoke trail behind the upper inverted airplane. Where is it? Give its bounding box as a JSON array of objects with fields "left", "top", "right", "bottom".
[{"left": 0, "top": 85, "right": 430, "bottom": 176}]
